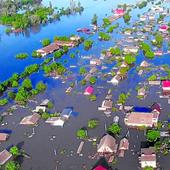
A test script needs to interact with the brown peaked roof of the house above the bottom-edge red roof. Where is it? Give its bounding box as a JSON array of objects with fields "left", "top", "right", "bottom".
[{"left": 97, "top": 134, "right": 116, "bottom": 152}]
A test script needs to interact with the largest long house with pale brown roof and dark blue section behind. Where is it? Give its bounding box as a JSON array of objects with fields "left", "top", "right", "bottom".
[{"left": 124, "top": 103, "right": 161, "bottom": 127}]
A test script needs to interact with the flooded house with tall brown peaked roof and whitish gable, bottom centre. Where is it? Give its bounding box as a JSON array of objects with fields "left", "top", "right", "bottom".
[{"left": 97, "top": 134, "right": 117, "bottom": 154}]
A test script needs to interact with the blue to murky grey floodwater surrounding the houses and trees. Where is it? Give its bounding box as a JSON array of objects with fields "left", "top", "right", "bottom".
[{"left": 0, "top": 0, "right": 170, "bottom": 170}]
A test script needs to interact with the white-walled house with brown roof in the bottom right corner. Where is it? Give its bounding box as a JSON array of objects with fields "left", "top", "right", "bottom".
[{"left": 139, "top": 147, "right": 157, "bottom": 168}]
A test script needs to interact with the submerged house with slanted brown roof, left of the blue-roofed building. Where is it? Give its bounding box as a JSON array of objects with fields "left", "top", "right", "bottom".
[{"left": 20, "top": 113, "right": 41, "bottom": 125}]
